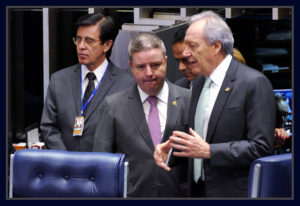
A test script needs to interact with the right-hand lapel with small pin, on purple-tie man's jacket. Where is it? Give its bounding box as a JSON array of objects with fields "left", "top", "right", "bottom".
[{"left": 162, "top": 83, "right": 181, "bottom": 142}]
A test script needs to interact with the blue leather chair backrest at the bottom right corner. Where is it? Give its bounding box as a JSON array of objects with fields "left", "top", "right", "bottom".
[{"left": 248, "top": 153, "right": 292, "bottom": 198}]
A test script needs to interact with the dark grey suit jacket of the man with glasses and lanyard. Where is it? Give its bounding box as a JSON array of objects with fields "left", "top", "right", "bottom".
[{"left": 40, "top": 62, "right": 135, "bottom": 151}]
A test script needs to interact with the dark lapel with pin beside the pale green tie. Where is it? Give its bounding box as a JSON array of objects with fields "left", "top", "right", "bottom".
[{"left": 206, "top": 59, "right": 237, "bottom": 142}]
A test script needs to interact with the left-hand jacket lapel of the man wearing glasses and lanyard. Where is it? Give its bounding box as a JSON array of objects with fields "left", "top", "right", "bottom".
[{"left": 71, "top": 64, "right": 81, "bottom": 115}]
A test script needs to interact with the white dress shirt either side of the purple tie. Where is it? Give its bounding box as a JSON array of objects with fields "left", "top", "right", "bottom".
[{"left": 138, "top": 82, "right": 169, "bottom": 137}]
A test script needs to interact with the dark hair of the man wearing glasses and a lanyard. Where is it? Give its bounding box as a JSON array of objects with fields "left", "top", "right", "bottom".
[{"left": 76, "top": 13, "right": 119, "bottom": 57}]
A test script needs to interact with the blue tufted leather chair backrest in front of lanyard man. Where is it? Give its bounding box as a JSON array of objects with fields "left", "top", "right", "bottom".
[{"left": 10, "top": 149, "right": 128, "bottom": 197}]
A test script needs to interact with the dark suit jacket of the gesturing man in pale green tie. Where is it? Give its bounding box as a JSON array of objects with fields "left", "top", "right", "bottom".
[{"left": 189, "top": 58, "right": 275, "bottom": 197}]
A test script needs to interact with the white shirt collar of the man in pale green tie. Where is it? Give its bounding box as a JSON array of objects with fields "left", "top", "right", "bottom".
[{"left": 209, "top": 54, "right": 232, "bottom": 86}]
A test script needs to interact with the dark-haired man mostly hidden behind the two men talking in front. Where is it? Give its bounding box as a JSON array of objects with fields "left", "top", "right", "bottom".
[{"left": 172, "top": 27, "right": 197, "bottom": 89}]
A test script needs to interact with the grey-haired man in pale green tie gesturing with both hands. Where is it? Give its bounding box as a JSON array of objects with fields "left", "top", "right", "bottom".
[{"left": 154, "top": 11, "right": 275, "bottom": 197}]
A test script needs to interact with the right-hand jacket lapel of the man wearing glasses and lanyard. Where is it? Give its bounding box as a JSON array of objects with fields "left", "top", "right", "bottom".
[{"left": 85, "top": 63, "right": 117, "bottom": 121}]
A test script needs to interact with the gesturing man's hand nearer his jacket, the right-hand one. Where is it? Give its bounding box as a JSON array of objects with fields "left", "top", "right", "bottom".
[{"left": 170, "top": 128, "right": 210, "bottom": 159}]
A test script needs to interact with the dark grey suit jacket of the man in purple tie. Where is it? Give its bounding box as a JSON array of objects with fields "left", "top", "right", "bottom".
[{"left": 93, "top": 83, "right": 190, "bottom": 197}]
